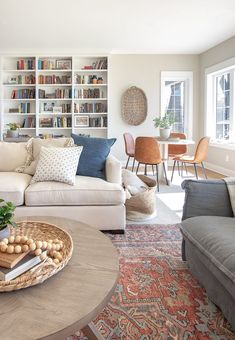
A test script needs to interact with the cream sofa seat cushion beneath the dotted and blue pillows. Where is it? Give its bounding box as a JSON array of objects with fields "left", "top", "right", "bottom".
[{"left": 25, "top": 176, "right": 125, "bottom": 206}]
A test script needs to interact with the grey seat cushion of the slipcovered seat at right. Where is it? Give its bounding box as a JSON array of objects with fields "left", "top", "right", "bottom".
[{"left": 181, "top": 216, "right": 235, "bottom": 283}]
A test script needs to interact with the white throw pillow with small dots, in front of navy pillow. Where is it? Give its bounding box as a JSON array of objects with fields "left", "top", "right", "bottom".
[{"left": 31, "top": 146, "right": 82, "bottom": 185}]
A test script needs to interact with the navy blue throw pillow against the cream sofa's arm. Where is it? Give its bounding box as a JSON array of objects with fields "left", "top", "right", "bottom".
[{"left": 71, "top": 133, "right": 116, "bottom": 179}]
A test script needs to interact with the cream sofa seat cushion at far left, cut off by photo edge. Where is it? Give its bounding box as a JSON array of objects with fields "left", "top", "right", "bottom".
[{"left": 0, "top": 172, "right": 31, "bottom": 206}]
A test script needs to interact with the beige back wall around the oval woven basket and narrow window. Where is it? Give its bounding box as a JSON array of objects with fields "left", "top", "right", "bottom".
[{"left": 109, "top": 55, "right": 199, "bottom": 160}]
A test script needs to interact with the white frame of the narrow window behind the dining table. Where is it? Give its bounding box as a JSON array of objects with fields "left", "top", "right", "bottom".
[{"left": 160, "top": 71, "right": 193, "bottom": 139}]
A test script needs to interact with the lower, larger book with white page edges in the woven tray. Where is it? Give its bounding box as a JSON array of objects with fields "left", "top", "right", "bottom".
[{"left": 0, "top": 251, "right": 46, "bottom": 281}]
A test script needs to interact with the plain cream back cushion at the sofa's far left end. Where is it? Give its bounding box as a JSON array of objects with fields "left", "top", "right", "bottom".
[{"left": 0, "top": 142, "right": 27, "bottom": 171}]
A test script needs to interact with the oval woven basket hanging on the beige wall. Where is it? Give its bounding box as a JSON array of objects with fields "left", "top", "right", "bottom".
[{"left": 121, "top": 86, "right": 148, "bottom": 125}]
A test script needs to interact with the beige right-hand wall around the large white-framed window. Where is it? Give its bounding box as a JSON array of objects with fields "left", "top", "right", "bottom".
[{"left": 199, "top": 36, "right": 235, "bottom": 176}]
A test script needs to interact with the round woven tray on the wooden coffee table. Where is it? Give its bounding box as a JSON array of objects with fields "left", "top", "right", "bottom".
[{"left": 0, "top": 221, "right": 73, "bottom": 292}]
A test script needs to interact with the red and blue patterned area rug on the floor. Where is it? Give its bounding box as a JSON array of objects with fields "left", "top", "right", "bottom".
[{"left": 69, "top": 225, "right": 235, "bottom": 340}]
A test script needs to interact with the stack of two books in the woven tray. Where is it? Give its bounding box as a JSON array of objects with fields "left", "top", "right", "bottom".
[{"left": 0, "top": 248, "right": 45, "bottom": 281}]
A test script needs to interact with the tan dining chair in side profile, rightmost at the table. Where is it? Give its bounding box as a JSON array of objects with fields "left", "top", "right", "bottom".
[{"left": 171, "top": 137, "right": 210, "bottom": 181}]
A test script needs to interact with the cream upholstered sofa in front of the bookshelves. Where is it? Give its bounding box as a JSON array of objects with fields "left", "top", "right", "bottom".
[{"left": 0, "top": 142, "right": 125, "bottom": 230}]
